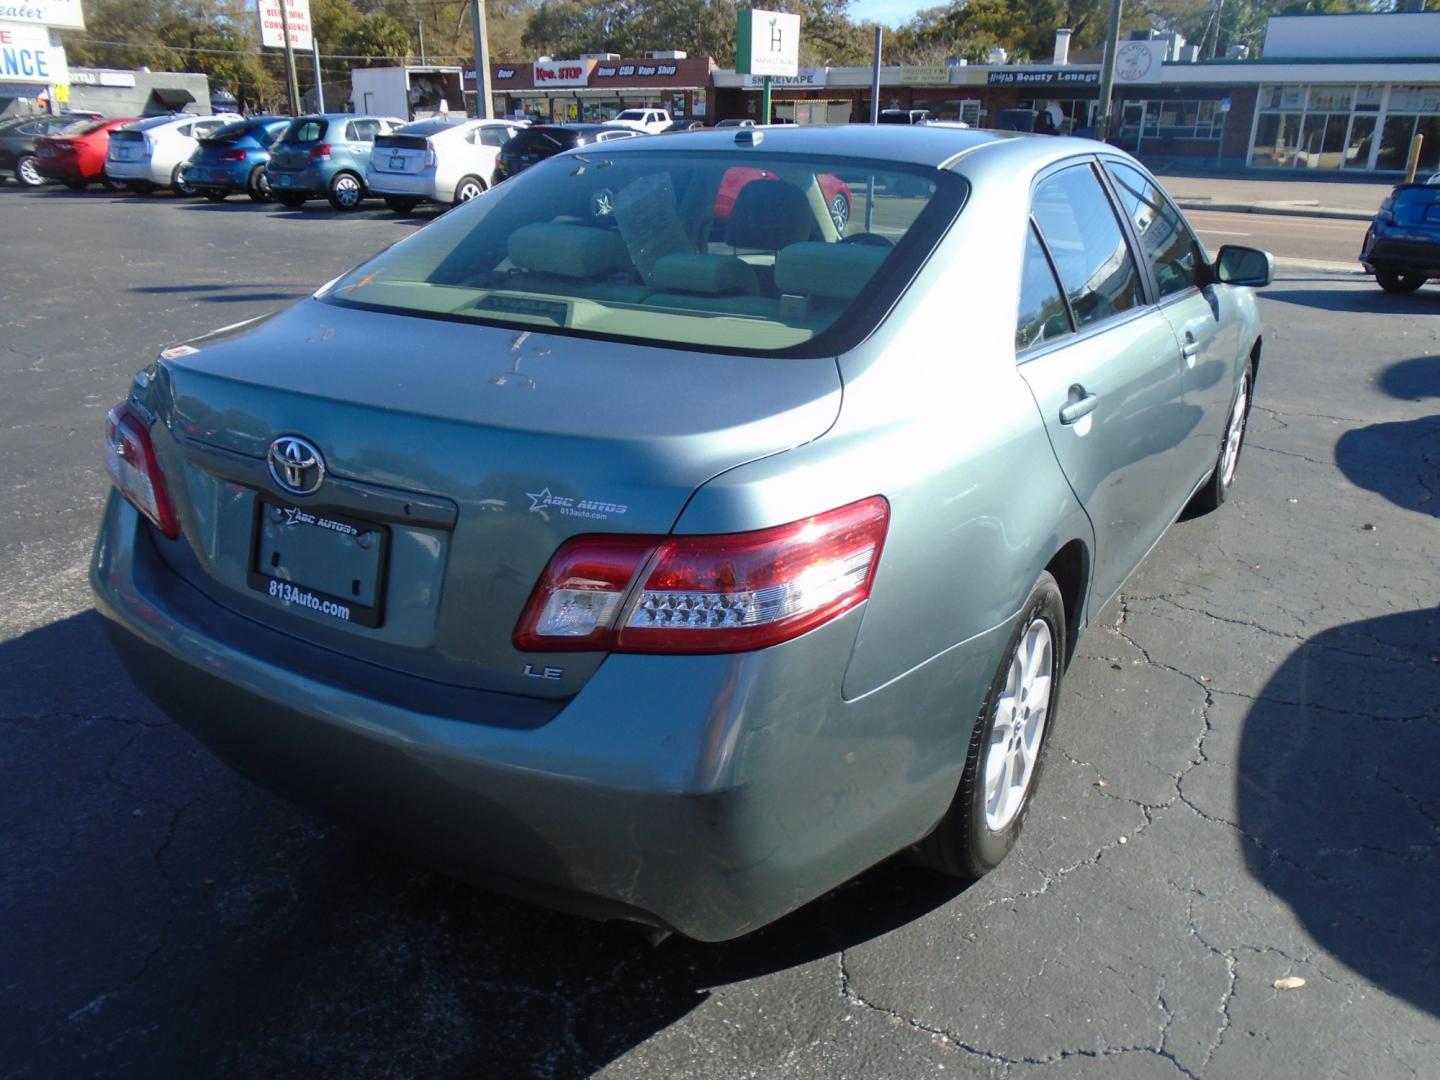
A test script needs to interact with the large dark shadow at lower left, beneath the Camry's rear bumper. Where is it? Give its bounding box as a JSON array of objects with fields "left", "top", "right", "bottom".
[{"left": 0, "top": 612, "right": 962, "bottom": 1077}]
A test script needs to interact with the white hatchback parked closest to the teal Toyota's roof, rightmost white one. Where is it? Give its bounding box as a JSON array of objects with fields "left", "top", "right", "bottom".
[{"left": 364, "top": 120, "right": 526, "bottom": 213}]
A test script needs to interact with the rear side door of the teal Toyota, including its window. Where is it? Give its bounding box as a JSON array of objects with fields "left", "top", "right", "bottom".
[{"left": 1017, "top": 158, "right": 1187, "bottom": 602}]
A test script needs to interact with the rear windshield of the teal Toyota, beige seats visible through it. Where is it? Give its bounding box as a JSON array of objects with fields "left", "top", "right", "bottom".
[{"left": 325, "top": 152, "right": 966, "bottom": 356}]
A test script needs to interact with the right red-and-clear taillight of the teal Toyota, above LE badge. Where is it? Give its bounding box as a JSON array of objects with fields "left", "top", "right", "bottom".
[{"left": 514, "top": 495, "right": 890, "bottom": 652}]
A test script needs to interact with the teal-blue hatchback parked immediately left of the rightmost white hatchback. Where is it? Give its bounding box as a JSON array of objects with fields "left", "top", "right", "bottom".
[{"left": 265, "top": 112, "right": 405, "bottom": 210}]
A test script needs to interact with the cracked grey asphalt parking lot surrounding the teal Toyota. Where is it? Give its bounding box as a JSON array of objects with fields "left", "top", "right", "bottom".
[{"left": 0, "top": 189, "right": 1440, "bottom": 1080}]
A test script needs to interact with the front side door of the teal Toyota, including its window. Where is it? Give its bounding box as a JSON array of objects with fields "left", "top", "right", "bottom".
[{"left": 1104, "top": 158, "right": 1240, "bottom": 485}]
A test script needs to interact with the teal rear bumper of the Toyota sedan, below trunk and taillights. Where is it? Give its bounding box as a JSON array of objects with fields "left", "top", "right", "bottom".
[{"left": 91, "top": 495, "right": 1008, "bottom": 940}]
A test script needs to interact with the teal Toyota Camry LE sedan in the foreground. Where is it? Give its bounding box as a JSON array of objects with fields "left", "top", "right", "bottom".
[{"left": 91, "top": 125, "right": 1273, "bottom": 940}]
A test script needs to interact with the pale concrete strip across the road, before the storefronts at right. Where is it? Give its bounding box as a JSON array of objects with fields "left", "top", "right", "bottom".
[{"left": 1155, "top": 170, "right": 1394, "bottom": 222}]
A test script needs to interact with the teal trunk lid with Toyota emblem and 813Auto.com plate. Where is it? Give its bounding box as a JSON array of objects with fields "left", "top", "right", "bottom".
[{"left": 140, "top": 301, "right": 841, "bottom": 698}]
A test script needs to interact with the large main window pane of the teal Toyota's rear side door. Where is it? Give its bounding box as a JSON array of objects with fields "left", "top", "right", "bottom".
[{"left": 1034, "top": 166, "right": 1145, "bottom": 327}]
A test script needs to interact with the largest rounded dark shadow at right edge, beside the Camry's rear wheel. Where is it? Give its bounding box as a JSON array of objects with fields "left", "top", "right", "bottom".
[{"left": 1236, "top": 608, "right": 1440, "bottom": 1015}]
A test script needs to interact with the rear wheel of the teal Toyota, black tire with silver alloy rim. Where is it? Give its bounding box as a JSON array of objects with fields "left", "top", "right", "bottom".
[{"left": 919, "top": 573, "right": 1066, "bottom": 881}]
